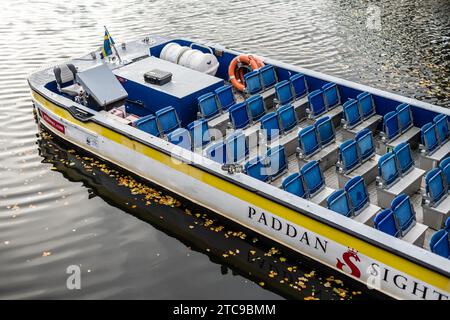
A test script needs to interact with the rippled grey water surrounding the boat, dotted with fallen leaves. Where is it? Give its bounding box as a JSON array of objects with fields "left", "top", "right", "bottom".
[{"left": 0, "top": 0, "right": 450, "bottom": 299}]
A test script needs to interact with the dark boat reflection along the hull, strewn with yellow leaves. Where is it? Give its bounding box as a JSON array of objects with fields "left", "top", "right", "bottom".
[{"left": 38, "top": 125, "right": 386, "bottom": 300}]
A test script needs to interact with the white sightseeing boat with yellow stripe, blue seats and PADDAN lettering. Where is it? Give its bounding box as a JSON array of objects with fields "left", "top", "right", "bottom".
[{"left": 28, "top": 31, "right": 450, "bottom": 300}]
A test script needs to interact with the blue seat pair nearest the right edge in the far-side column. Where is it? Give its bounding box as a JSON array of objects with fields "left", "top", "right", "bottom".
[{"left": 420, "top": 114, "right": 450, "bottom": 153}]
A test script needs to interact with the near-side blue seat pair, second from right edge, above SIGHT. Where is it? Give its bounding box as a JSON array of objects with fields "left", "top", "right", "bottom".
[{"left": 374, "top": 193, "right": 416, "bottom": 237}]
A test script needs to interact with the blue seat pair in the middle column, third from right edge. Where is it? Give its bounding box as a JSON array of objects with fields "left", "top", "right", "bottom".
[{"left": 338, "top": 128, "right": 375, "bottom": 173}]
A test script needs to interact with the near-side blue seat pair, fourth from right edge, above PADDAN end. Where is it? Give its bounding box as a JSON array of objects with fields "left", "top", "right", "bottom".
[{"left": 281, "top": 160, "right": 325, "bottom": 199}]
